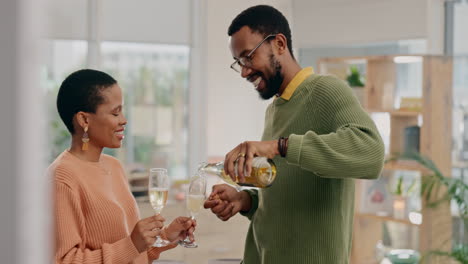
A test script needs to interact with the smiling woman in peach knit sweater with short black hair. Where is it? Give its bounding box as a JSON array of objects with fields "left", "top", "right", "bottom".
[{"left": 48, "top": 70, "right": 195, "bottom": 264}]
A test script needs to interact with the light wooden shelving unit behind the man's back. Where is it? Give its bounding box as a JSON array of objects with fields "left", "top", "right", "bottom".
[{"left": 318, "top": 55, "right": 452, "bottom": 264}]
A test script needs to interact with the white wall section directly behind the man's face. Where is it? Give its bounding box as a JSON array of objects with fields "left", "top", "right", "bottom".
[{"left": 203, "top": 0, "right": 291, "bottom": 157}]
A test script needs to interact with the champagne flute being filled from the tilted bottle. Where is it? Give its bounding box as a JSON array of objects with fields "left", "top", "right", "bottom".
[{"left": 179, "top": 174, "right": 206, "bottom": 248}]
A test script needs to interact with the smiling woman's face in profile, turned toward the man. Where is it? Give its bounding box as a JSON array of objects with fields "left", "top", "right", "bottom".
[{"left": 88, "top": 84, "right": 127, "bottom": 148}]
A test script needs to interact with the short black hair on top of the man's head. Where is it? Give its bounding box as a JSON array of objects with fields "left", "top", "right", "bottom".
[{"left": 228, "top": 5, "right": 294, "bottom": 58}]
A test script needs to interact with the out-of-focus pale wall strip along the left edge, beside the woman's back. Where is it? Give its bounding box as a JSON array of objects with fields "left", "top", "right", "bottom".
[{"left": 0, "top": 0, "right": 52, "bottom": 264}]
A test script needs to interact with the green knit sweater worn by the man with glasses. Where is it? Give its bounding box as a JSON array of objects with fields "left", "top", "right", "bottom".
[{"left": 243, "top": 74, "right": 384, "bottom": 264}]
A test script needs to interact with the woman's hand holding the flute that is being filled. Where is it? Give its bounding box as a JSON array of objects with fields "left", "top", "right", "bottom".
[{"left": 163, "top": 216, "right": 197, "bottom": 242}]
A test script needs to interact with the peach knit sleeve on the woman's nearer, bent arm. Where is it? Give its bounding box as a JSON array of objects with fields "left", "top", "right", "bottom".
[{"left": 55, "top": 178, "right": 140, "bottom": 264}]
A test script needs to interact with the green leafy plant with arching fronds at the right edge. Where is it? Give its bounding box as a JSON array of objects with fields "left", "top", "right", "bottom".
[{"left": 387, "top": 152, "right": 468, "bottom": 264}]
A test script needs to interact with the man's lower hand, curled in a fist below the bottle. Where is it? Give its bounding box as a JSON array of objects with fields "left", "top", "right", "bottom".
[{"left": 203, "top": 184, "right": 251, "bottom": 221}]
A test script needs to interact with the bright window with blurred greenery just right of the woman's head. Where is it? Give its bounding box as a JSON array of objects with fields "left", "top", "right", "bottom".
[{"left": 101, "top": 42, "right": 189, "bottom": 178}]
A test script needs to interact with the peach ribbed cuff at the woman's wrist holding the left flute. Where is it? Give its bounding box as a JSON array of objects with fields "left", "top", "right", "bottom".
[{"left": 103, "top": 236, "right": 140, "bottom": 263}]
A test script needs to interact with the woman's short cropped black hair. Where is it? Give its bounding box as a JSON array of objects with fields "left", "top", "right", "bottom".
[{"left": 57, "top": 69, "right": 117, "bottom": 135}]
